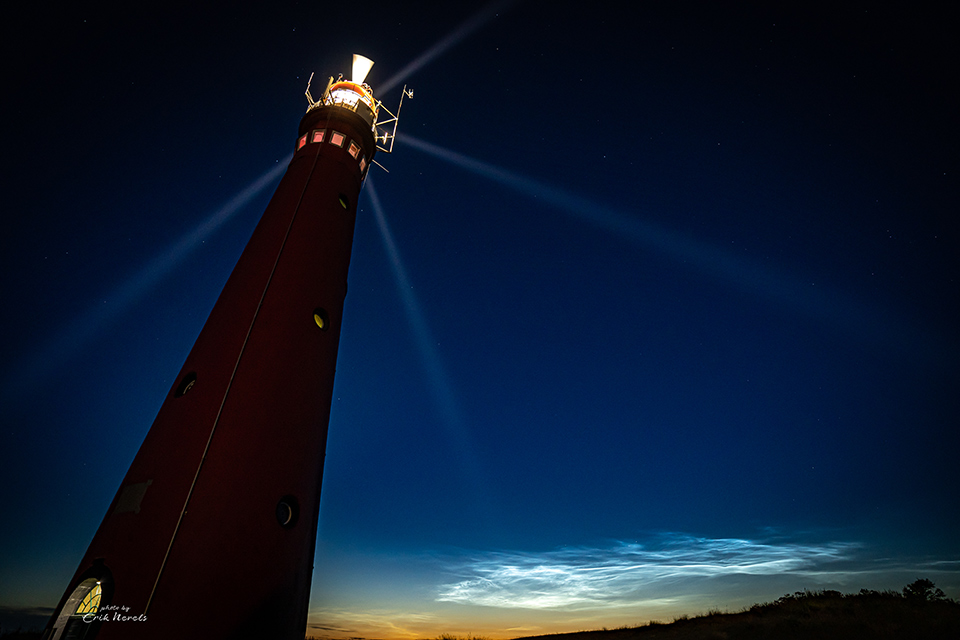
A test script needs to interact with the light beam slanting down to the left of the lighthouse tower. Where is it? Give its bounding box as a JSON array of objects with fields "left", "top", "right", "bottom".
[{"left": 2, "top": 154, "right": 293, "bottom": 403}]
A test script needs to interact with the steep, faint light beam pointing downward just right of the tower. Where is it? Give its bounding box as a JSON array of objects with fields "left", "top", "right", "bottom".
[{"left": 365, "top": 177, "right": 492, "bottom": 523}]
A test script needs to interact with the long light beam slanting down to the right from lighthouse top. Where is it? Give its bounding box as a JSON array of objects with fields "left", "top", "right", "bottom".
[{"left": 397, "top": 133, "right": 942, "bottom": 360}]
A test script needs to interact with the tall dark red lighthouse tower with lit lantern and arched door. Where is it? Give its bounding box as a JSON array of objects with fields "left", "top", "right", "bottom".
[{"left": 44, "top": 56, "right": 402, "bottom": 640}]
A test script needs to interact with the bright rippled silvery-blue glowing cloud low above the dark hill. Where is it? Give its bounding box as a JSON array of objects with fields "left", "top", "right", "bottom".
[{"left": 437, "top": 535, "right": 859, "bottom": 610}]
